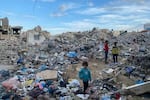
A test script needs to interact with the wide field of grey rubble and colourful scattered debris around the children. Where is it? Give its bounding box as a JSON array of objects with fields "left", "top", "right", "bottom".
[{"left": 0, "top": 26, "right": 150, "bottom": 100}]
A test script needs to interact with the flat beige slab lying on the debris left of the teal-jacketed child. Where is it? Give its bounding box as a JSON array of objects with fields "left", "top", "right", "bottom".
[{"left": 36, "top": 70, "right": 57, "bottom": 80}]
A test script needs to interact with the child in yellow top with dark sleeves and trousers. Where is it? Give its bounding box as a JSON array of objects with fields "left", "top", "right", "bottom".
[{"left": 112, "top": 42, "right": 119, "bottom": 63}]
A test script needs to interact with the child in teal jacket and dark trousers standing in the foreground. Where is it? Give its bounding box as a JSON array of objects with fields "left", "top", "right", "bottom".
[{"left": 79, "top": 61, "right": 91, "bottom": 94}]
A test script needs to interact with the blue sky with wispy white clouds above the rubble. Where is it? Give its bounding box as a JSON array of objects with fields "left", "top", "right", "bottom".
[{"left": 0, "top": 0, "right": 150, "bottom": 34}]
